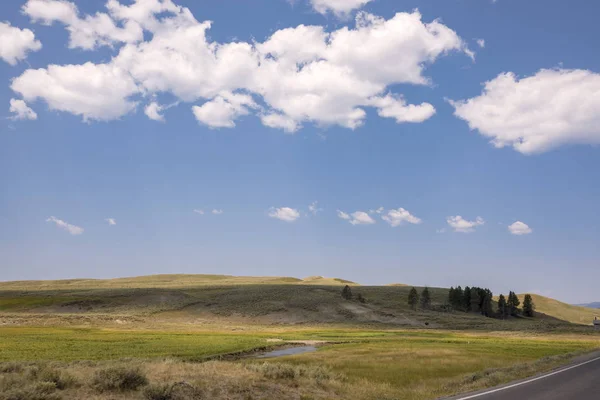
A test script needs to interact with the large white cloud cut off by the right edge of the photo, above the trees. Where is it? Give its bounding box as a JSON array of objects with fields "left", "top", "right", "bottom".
[{"left": 451, "top": 69, "right": 600, "bottom": 154}]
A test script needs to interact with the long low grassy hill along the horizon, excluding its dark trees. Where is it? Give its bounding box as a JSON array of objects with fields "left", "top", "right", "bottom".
[{"left": 0, "top": 275, "right": 600, "bottom": 329}]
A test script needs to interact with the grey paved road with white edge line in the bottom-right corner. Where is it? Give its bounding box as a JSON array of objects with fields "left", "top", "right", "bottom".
[{"left": 452, "top": 353, "right": 600, "bottom": 400}]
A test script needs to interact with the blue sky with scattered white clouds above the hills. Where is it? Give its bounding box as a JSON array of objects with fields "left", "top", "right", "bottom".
[{"left": 0, "top": 0, "right": 600, "bottom": 302}]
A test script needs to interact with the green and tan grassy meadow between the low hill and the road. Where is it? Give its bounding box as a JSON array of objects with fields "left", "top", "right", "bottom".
[{"left": 0, "top": 327, "right": 600, "bottom": 400}]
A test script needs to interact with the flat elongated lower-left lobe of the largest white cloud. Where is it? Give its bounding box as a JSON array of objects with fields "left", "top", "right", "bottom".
[{"left": 11, "top": 62, "right": 139, "bottom": 121}]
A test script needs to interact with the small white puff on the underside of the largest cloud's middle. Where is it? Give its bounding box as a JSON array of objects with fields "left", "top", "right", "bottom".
[{"left": 192, "top": 93, "right": 257, "bottom": 128}]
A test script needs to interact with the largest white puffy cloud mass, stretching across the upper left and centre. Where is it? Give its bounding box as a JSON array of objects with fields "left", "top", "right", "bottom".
[{"left": 12, "top": 0, "right": 471, "bottom": 128}]
